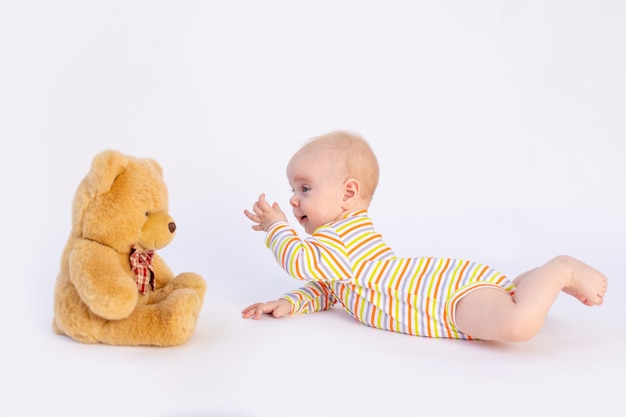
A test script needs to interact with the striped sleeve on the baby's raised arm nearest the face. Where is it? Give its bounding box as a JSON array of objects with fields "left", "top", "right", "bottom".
[{"left": 265, "top": 222, "right": 352, "bottom": 281}]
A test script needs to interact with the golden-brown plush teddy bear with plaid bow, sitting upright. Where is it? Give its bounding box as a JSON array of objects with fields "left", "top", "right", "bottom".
[{"left": 53, "top": 150, "right": 206, "bottom": 346}]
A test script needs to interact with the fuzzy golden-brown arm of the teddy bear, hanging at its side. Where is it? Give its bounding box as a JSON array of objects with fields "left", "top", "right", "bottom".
[{"left": 69, "top": 239, "right": 138, "bottom": 320}]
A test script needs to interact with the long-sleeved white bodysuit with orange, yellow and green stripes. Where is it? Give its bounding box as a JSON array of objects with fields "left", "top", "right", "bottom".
[{"left": 266, "top": 210, "right": 515, "bottom": 339}]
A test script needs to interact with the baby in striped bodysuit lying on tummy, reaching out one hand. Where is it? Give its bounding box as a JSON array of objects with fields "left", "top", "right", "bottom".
[{"left": 242, "top": 131, "right": 608, "bottom": 342}]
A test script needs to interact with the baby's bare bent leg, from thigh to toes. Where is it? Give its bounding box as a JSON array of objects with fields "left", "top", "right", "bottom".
[{"left": 455, "top": 256, "right": 607, "bottom": 342}]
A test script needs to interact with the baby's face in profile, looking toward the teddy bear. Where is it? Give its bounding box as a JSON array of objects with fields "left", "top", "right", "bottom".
[{"left": 287, "top": 149, "right": 347, "bottom": 234}]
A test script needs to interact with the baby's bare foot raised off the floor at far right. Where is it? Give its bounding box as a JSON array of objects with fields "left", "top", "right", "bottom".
[{"left": 556, "top": 255, "right": 608, "bottom": 306}]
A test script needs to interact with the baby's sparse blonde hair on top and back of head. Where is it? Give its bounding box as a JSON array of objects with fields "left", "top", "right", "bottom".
[{"left": 299, "top": 130, "right": 379, "bottom": 201}]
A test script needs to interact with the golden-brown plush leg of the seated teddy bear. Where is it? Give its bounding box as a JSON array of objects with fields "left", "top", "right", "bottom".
[{"left": 98, "top": 289, "right": 200, "bottom": 346}]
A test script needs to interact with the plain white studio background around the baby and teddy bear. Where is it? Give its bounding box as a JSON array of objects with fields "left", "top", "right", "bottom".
[{"left": 0, "top": 0, "right": 626, "bottom": 417}]
